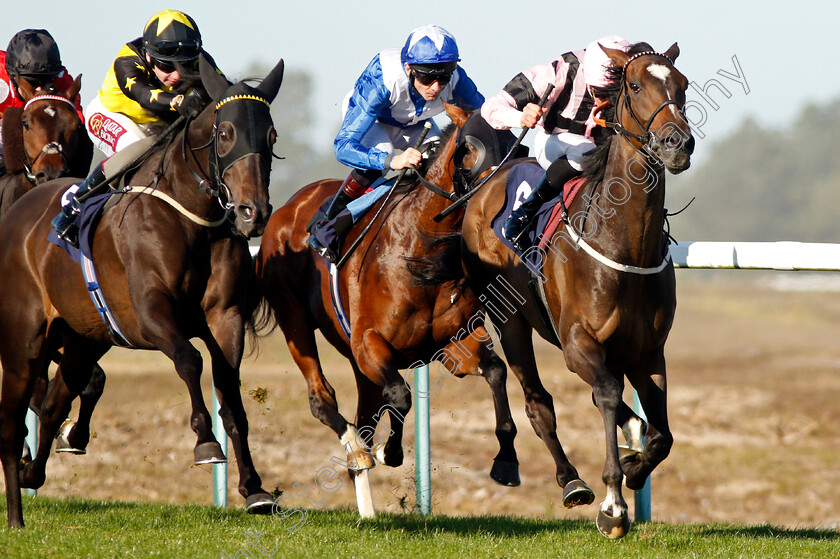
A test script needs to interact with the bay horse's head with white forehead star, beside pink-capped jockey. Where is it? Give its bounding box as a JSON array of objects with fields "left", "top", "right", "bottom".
[{"left": 601, "top": 43, "right": 694, "bottom": 174}]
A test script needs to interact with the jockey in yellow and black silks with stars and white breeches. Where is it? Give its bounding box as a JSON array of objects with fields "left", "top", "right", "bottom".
[{"left": 52, "top": 10, "right": 221, "bottom": 245}]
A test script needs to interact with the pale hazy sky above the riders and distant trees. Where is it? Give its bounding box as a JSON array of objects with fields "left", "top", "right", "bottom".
[{"left": 0, "top": 0, "right": 840, "bottom": 161}]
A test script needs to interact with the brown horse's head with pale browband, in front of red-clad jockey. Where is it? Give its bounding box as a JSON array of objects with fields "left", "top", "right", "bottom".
[{"left": 4, "top": 75, "right": 92, "bottom": 184}]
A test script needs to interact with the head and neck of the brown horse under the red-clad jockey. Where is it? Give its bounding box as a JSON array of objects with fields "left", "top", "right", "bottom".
[{"left": 0, "top": 75, "right": 93, "bottom": 219}]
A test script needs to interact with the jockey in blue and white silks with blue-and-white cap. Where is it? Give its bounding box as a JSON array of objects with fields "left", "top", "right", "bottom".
[{"left": 309, "top": 25, "right": 484, "bottom": 262}]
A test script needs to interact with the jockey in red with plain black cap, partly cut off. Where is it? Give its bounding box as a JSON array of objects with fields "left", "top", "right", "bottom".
[{"left": 0, "top": 29, "right": 84, "bottom": 166}]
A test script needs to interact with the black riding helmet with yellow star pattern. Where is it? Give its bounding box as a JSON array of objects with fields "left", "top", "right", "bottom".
[{"left": 143, "top": 10, "right": 201, "bottom": 62}]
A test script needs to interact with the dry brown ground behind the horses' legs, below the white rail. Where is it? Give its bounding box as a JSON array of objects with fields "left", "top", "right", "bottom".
[{"left": 6, "top": 278, "right": 840, "bottom": 529}]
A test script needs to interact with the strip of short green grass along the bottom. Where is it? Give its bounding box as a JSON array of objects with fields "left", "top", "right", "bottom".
[{"left": 0, "top": 497, "right": 840, "bottom": 559}]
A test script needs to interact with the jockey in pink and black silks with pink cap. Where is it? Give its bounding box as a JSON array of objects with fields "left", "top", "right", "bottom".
[{"left": 481, "top": 35, "right": 630, "bottom": 250}]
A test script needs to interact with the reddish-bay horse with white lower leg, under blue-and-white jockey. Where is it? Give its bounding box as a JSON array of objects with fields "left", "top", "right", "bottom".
[{"left": 256, "top": 106, "right": 519, "bottom": 517}]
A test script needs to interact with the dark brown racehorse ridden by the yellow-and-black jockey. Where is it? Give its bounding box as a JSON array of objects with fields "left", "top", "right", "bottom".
[{"left": 0, "top": 57, "right": 283, "bottom": 526}]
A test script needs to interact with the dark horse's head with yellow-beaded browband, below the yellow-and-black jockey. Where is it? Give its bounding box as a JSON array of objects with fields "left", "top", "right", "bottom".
[{"left": 201, "top": 57, "right": 284, "bottom": 237}]
